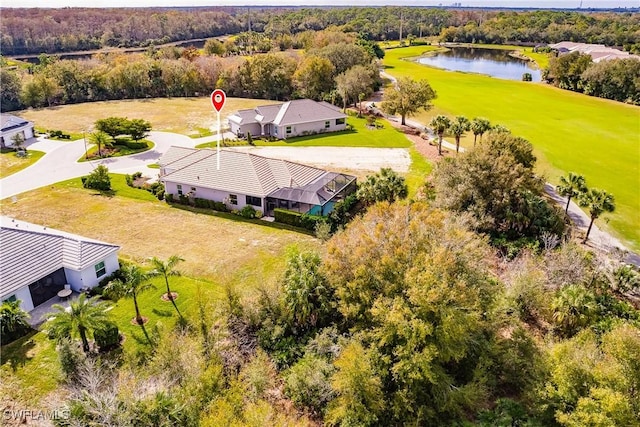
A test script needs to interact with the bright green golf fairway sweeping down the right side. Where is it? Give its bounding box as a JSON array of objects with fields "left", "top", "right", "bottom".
[{"left": 384, "top": 46, "right": 640, "bottom": 250}]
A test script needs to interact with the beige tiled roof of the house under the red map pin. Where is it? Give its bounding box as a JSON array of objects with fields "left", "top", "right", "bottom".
[{"left": 158, "top": 147, "right": 326, "bottom": 197}]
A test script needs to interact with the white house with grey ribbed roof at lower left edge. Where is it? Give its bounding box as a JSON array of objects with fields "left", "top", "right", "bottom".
[{"left": 0, "top": 216, "right": 120, "bottom": 311}]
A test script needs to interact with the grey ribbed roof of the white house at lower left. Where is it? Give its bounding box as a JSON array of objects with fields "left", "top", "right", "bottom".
[{"left": 0, "top": 216, "right": 120, "bottom": 298}]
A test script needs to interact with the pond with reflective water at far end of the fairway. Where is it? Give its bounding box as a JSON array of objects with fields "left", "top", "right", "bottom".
[{"left": 418, "top": 47, "right": 541, "bottom": 82}]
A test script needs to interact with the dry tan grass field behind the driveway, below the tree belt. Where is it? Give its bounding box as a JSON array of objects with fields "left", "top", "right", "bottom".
[{"left": 16, "top": 96, "right": 272, "bottom": 137}]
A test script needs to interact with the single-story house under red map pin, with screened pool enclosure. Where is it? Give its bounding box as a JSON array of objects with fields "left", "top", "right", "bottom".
[{"left": 158, "top": 147, "right": 356, "bottom": 216}]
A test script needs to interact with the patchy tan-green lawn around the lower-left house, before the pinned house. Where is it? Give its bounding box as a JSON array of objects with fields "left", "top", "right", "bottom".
[{"left": 0, "top": 174, "right": 323, "bottom": 409}]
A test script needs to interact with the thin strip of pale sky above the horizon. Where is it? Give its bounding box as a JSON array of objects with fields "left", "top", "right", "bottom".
[{"left": 0, "top": 0, "right": 640, "bottom": 9}]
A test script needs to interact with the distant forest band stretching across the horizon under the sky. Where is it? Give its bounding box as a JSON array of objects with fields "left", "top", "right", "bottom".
[{"left": 0, "top": 7, "right": 640, "bottom": 55}]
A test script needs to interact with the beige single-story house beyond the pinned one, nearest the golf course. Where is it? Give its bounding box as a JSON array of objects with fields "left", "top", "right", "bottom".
[{"left": 227, "top": 99, "right": 347, "bottom": 139}]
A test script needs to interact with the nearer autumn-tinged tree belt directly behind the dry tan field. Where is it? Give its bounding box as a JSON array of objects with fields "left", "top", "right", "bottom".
[{"left": 0, "top": 32, "right": 383, "bottom": 111}]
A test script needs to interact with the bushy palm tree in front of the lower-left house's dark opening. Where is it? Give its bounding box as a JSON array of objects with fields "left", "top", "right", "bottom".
[{"left": 47, "top": 294, "right": 110, "bottom": 353}]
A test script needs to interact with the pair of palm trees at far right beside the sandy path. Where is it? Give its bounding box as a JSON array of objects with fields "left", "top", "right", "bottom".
[{"left": 556, "top": 172, "right": 616, "bottom": 242}]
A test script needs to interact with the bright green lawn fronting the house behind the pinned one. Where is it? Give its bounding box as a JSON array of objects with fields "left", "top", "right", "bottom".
[{"left": 197, "top": 115, "right": 411, "bottom": 148}]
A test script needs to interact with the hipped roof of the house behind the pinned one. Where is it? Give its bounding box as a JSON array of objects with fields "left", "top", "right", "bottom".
[{"left": 228, "top": 99, "right": 347, "bottom": 126}]
